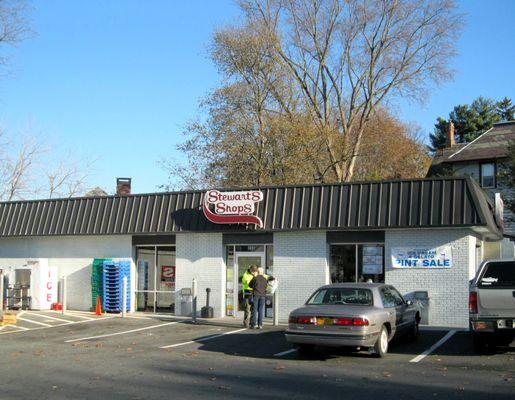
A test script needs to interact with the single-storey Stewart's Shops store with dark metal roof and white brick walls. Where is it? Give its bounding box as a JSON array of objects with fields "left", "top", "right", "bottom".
[{"left": 0, "top": 178, "right": 510, "bottom": 327}]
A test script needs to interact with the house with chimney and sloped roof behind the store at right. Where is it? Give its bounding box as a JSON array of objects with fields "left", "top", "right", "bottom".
[{"left": 429, "top": 121, "right": 515, "bottom": 258}]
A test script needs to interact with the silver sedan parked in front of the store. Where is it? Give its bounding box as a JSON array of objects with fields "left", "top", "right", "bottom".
[{"left": 286, "top": 283, "right": 420, "bottom": 357}]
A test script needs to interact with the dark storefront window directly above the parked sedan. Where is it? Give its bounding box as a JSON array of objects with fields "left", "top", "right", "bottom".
[{"left": 330, "top": 244, "right": 384, "bottom": 283}]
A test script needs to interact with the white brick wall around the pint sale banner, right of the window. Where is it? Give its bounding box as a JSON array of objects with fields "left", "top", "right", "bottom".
[{"left": 385, "top": 229, "right": 476, "bottom": 328}]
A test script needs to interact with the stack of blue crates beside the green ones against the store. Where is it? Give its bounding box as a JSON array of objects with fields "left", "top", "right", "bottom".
[{"left": 102, "top": 261, "right": 131, "bottom": 312}]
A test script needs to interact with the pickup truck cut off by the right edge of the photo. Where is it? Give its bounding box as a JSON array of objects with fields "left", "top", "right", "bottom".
[{"left": 469, "top": 260, "right": 515, "bottom": 352}]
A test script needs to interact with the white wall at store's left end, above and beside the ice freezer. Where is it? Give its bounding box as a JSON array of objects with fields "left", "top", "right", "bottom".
[{"left": 0, "top": 235, "right": 134, "bottom": 310}]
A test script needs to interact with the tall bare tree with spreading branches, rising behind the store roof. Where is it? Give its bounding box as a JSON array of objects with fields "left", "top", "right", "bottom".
[{"left": 240, "top": 0, "right": 462, "bottom": 181}]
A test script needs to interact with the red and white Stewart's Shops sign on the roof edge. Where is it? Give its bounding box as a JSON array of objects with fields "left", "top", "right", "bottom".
[{"left": 202, "top": 190, "right": 263, "bottom": 228}]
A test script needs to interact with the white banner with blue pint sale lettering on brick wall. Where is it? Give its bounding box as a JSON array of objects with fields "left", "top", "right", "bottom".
[{"left": 392, "top": 246, "right": 452, "bottom": 269}]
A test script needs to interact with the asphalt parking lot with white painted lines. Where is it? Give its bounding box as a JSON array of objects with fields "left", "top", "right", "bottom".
[{"left": 0, "top": 312, "right": 515, "bottom": 399}]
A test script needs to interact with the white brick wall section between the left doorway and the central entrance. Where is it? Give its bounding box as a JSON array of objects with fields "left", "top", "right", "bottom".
[{"left": 175, "top": 233, "right": 225, "bottom": 317}]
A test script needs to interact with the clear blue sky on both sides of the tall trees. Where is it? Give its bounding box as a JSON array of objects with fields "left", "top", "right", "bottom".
[{"left": 0, "top": 0, "right": 515, "bottom": 192}]
